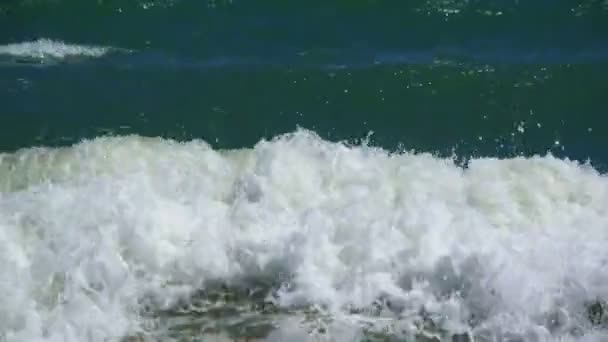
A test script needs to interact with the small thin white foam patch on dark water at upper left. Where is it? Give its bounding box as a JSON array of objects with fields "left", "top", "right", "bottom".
[{"left": 0, "top": 38, "right": 111, "bottom": 59}]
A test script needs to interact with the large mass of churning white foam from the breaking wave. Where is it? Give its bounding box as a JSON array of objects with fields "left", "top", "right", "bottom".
[{"left": 0, "top": 131, "right": 608, "bottom": 341}]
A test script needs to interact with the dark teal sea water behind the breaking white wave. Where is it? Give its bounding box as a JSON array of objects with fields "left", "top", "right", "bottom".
[{"left": 0, "top": 0, "right": 608, "bottom": 164}]
